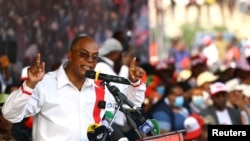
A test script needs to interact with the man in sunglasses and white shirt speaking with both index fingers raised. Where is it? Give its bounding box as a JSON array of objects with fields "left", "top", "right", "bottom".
[{"left": 2, "top": 35, "right": 146, "bottom": 141}]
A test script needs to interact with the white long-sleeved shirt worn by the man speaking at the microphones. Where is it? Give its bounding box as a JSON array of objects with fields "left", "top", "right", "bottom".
[{"left": 2, "top": 63, "right": 146, "bottom": 141}]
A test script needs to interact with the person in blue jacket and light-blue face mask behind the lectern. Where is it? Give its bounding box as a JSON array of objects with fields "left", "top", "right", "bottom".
[{"left": 148, "top": 84, "right": 189, "bottom": 133}]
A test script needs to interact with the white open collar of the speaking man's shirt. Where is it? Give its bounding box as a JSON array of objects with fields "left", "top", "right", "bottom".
[{"left": 56, "top": 62, "right": 94, "bottom": 88}]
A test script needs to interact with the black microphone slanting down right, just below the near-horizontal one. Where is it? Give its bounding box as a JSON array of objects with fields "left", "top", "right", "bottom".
[{"left": 106, "top": 84, "right": 137, "bottom": 109}]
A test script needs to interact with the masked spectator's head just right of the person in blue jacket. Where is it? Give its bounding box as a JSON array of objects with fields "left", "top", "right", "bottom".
[{"left": 189, "top": 87, "right": 207, "bottom": 113}]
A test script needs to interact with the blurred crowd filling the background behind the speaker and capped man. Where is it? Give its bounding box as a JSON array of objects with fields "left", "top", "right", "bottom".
[{"left": 0, "top": 0, "right": 250, "bottom": 140}]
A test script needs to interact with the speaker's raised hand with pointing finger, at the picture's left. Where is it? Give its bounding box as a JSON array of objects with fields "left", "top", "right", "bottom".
[{"left": 26, "top": 53, "right": 45, "bottom": 89}]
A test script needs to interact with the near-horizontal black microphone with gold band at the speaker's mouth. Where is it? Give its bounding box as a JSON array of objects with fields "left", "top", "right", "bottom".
[{"left": 85, "top": 70, "right": 130, "bottom": 85}]
